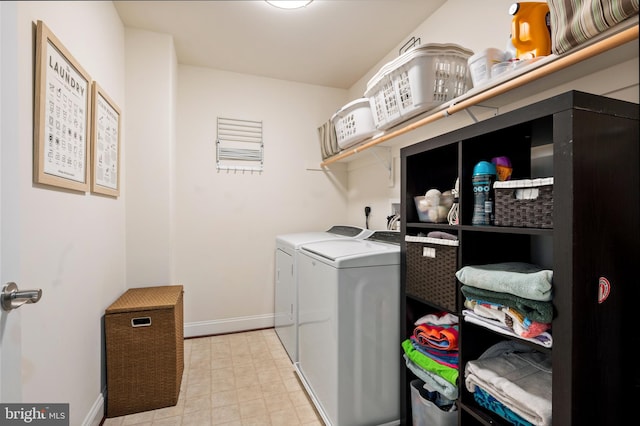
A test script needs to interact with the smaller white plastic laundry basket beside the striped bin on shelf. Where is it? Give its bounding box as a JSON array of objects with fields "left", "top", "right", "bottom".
[{"left": 331, "top": 98, "right": 377, "bottom": 149}]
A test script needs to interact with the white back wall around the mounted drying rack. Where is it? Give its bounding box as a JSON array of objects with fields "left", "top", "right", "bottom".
[{"left": 174, "top": 66, "right": 347, "bottom": 335}]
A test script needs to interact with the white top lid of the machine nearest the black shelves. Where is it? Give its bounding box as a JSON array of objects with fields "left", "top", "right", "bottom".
[{"left": 300, "top": 238, "right": 400, "bottom": 268}]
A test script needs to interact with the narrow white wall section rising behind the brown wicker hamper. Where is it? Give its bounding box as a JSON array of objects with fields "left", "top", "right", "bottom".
[{"left": 124, "top": 28, "right": 178, "bottom": 288}]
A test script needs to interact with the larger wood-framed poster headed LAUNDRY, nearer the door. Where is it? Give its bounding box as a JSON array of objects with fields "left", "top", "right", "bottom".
[{"left": 33, "top": 21, "right": 91, "bottom": 192}]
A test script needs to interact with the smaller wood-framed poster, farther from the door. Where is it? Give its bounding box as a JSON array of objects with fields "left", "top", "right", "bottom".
[{"left": 91, "top": 81, "right": 120, "bottom": 197}]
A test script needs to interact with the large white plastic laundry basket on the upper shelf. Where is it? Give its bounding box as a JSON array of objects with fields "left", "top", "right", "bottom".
[{"left": 364, "top": 43, "right": 473, "bottom": 130}]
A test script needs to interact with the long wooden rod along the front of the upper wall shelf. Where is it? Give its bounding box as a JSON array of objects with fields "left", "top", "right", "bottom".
[{"left": 320, "top": 15, "right": 638, "bottom": 167}]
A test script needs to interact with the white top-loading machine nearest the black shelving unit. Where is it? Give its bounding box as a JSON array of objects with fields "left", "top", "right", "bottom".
[{"left": 295, "top": 231, "right": 402, "bottom": 426}]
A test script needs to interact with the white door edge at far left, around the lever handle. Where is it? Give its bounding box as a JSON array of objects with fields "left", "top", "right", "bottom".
[{"left": 0, "top": 1, "right": 23, "bottom": 403}]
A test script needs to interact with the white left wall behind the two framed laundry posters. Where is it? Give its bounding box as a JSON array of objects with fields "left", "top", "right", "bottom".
[{"left": 10, "top": 1, "right": 126, "bottom": 424}]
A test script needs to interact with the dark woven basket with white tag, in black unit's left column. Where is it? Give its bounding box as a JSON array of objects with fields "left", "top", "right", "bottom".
[{"left": 405, "top": 235, "right": 458, "bottom": 312}]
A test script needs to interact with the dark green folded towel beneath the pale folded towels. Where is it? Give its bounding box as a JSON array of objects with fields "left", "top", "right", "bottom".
[{"left": 460, "top": 285, "right": 553, "bottom": 323}]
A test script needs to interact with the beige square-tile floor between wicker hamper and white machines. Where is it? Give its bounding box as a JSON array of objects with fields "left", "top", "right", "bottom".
[{"left": 103, "top": 328, "right": 324, "bottom": 426}]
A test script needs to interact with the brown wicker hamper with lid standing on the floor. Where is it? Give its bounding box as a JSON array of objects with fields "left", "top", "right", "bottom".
[{"left": 105, "top": 285, "right": 184, "bottom": 417}]
